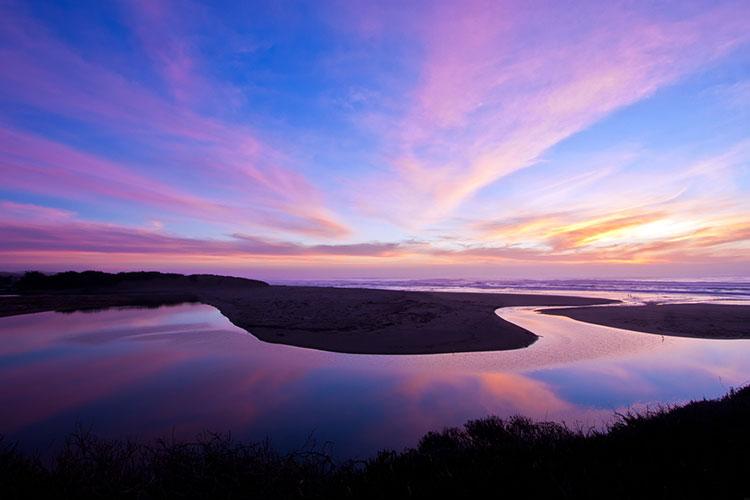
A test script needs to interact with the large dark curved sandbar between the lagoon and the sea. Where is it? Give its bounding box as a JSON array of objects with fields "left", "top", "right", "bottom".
[{"left": 0, "top": 283, "right": 610, "bottom": 354}]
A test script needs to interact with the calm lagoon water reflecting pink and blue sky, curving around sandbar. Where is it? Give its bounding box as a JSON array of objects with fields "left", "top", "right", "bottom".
[{"left": 0, "top": 294, "right": 750, "bottom": 457}]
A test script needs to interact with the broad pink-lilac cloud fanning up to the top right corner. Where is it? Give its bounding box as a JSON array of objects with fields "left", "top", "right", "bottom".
[{"left": 362, "top": 1, "right": 750, "bottom": 223}]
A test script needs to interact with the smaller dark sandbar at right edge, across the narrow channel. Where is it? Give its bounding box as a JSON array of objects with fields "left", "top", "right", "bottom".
[{"left": 542, "top": 304, "right": 750, "bottom": 339}]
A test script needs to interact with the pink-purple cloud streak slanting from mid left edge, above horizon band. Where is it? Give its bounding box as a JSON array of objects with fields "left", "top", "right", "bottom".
[{"left": 0, "top": 127, "right": 347, "bottom": 236}]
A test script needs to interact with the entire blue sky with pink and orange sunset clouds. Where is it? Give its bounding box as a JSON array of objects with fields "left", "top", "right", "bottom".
[{"left": 0, "top": 0, "right": 750, "bottom": 279}]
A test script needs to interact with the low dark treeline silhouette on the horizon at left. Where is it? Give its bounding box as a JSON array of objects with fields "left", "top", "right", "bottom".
[{"left": 14, "top": 271, "right": 269, "bottom": 293}]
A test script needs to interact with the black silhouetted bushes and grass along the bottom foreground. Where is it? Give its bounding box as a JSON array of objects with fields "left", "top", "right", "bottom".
[{"left": 0, "top": 387, "right": 750, "bottom": 499}]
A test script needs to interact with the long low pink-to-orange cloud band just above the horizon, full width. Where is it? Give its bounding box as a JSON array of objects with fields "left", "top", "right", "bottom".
[{"left": 0, "top": 202, "right": 750, "bottom": 266}]
